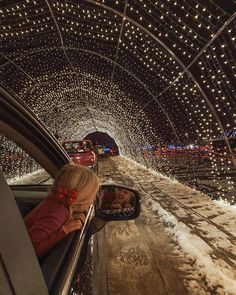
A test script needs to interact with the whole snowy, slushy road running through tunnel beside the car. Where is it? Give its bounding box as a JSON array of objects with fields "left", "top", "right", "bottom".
[{"left": 96, "top": 156, "right": 236, "bottom": 295}]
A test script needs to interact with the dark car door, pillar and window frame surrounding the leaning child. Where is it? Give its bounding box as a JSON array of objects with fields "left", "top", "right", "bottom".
[{"left": 0, "top": 89, "right": 86, "bottom": 295}]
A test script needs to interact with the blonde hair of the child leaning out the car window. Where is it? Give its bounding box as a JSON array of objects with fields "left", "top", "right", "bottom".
[{"left": 49, "top": 164, "right": 99, "bottom": 204}]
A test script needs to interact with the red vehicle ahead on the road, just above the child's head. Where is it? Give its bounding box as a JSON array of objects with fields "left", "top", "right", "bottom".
[{"left": 62, "top": 140, "right": 98, "bottom": 172}]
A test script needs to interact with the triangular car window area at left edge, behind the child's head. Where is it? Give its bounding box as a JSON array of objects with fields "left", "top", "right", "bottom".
[{"left": 0, "top": 133, "right": 52, "bottom": 185}]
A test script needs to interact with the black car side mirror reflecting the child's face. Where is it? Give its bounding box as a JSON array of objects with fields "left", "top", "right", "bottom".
[{"left": 95, "top": 184, "right": 141, "bottom": 221}]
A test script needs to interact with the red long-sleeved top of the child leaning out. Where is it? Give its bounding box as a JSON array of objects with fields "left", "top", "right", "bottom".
[{"left": 28, "top": 211, "right": 67, "bottom": 256}]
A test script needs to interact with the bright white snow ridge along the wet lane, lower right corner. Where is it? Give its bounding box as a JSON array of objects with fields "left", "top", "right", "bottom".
[{"left": 152, "top": 203, "right": 236, "bottom": 295}]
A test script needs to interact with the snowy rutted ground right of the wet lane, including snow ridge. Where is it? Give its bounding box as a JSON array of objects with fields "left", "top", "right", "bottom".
[{"left": 98, "top": 157, "right": 236, "bottom": 295}]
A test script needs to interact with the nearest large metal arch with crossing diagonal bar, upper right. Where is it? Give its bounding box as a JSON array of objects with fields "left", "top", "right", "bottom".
[{"left": 85, "top": 0, "right": 236, "bottom": 168}]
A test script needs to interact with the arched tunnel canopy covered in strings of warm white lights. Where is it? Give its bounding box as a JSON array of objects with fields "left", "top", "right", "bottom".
[{"left": 0, "top": 0, "right": 236, "bottom": 203}]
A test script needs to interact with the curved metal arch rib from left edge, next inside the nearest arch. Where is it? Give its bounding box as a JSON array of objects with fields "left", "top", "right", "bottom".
[{"left": 0, "top": 47, "right": 180, "bottom": 142}]
